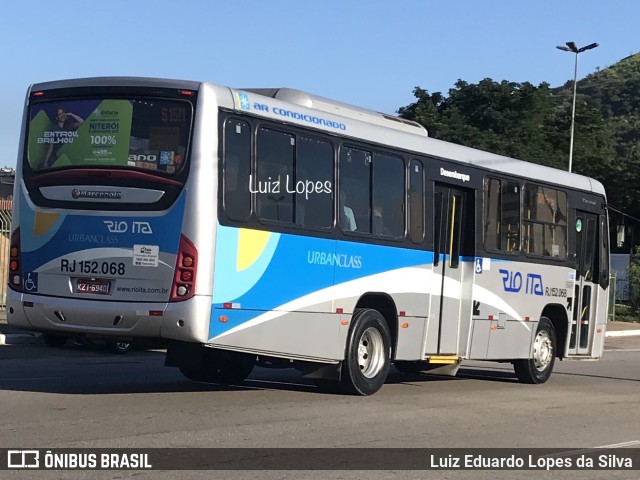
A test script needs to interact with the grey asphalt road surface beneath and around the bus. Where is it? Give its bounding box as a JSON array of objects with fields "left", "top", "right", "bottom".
[{"left": 0, "top": 336, "right": 640, "bottom": 479}]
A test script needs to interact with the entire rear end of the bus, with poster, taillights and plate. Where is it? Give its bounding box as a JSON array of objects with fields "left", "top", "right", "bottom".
[{"left": 8, "top": 81, "right": 210, "bottom": 341}]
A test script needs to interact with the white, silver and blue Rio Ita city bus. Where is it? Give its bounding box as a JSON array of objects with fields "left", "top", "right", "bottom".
[{"left": 7, "top": 78, "right": 609, "bottom": 395}]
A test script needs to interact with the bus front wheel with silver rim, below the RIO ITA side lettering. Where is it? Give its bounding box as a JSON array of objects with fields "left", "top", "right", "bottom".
[{"left": 513, "top": 317, "right": 556, "bottom": 384}]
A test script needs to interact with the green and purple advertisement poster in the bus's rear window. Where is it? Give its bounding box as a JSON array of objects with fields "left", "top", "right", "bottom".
[{"left": 28, "top": 99, "right": 133, "bottom": 170}]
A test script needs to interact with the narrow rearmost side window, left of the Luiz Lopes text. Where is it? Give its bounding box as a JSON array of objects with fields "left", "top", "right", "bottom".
[{"left": 223, "top": 119, "right": 251, "bottom": 221}]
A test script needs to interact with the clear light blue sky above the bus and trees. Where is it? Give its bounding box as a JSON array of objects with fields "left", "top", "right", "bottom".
[{"left": 0, "top": 0, "right": 640, "bottom": 168}]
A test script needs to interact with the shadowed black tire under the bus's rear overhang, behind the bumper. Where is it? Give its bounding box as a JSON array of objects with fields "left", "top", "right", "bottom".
[{"left": 179, "top": 347, "right": 256, "bottom": 384}]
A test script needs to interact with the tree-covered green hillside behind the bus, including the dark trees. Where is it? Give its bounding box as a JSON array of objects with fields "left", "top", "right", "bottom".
[{"left": 398, "top": 54, "right": 640, "bottom": 248}]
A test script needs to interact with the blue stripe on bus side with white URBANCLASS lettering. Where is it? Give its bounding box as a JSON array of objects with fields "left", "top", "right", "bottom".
[{"left": 213, "top": 226, "right": 433, "bottom": 322}]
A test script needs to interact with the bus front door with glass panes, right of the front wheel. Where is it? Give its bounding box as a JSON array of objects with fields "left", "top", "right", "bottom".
[{"left": 569, "top": 211, "right": 600, "bottom": 355}]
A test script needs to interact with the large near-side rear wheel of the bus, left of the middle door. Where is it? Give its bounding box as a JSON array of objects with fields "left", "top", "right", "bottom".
[{"left": 340, "top": 308, "right": 391, "bottom": 395}]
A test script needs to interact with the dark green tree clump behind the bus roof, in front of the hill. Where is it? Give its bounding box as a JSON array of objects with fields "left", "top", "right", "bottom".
[{"left": 398, "top": 78, "right": 616, "bottom": 197}]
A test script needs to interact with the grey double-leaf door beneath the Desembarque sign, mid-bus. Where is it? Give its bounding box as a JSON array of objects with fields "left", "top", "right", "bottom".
[{"left": 425, "top": 184, "right": 474, "bottom": 355}]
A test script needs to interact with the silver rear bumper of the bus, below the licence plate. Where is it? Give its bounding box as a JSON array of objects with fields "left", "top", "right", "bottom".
[{"left": 7, "top": 289, "right": 211, "bottom": 343}]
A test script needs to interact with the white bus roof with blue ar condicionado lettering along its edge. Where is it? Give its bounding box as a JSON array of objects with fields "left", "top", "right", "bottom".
[{"left": 30, "top": 77, "right": 605, "bottom": 196}]
